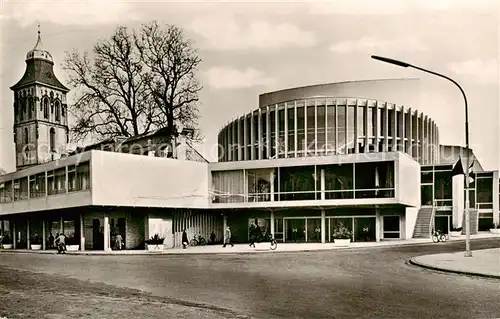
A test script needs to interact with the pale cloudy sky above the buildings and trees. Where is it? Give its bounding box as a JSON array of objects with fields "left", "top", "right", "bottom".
[{"left": 0, "top": 0, "right": 500, "bottom": 171}]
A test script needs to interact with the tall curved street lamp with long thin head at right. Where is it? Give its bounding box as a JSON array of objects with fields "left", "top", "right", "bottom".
[{"left": 371, "top": 55, "right": 472, "bottom": 257}]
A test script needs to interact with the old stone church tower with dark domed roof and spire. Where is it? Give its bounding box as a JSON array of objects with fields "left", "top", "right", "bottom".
[{"left": 10, "top": 30, "right": 69, "bottom": 169}]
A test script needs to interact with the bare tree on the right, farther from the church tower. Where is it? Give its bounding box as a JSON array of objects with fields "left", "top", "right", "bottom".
[{"left": 135, "top": 21, "right": 202, "bottom": 141}]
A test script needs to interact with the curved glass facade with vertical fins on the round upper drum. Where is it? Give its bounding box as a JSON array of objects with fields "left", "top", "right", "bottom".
[{"left": 218, "top": 97, "right": 439, "bottom": 164}]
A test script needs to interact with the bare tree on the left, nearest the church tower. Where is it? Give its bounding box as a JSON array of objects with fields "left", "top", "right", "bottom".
[{"left": 63, "top": 26, "right": 158, "bottom": 141}]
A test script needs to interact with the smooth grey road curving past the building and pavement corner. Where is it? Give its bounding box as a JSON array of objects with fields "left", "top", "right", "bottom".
[{"left": 0, "top": 239, "right": 500, "bottom": 318}]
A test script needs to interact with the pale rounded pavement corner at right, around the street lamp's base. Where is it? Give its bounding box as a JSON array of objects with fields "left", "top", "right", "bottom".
[{"left": 410, "top": 248, "right": 500, "bottom": 279}]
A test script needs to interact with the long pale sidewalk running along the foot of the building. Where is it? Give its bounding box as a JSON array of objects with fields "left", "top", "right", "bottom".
[{"left": 0, "top": 233, "right": 500, "bottom": 255}]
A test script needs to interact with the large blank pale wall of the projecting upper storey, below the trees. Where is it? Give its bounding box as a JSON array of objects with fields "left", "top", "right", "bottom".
[{"left": 91, "top": 151, "right": 208, "bottom": 208}]
